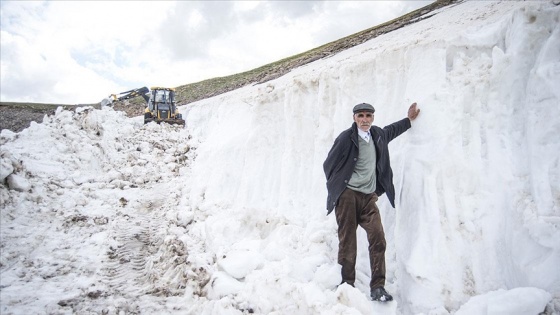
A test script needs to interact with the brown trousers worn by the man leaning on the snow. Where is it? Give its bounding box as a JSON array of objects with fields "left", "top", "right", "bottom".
[{"left": 335, "top": 188, "right": 386, "bottom": 289}]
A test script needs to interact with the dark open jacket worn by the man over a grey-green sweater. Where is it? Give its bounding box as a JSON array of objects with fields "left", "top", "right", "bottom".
[{"left": 323, "top": 118, "right": 410, "bottom": 215}]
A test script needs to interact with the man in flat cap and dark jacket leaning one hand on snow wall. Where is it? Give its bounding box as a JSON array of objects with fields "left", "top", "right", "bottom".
[{"left": 323, "top": 103, "right": 420, "bottom": 301}]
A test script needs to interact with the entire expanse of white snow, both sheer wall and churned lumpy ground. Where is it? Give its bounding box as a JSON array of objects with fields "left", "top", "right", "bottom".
[{"left": 0, "top": 1, "right": 560, "bottom": 315}]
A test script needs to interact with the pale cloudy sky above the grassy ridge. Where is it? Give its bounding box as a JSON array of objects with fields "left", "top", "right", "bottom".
[{"left": 0, "top": 1, "right": 432, "bottom": 104}]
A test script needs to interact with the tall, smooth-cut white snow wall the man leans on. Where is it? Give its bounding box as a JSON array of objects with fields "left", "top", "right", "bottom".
[{"left": 183, "top": 2, "right": 560, "bottom": 314}]
